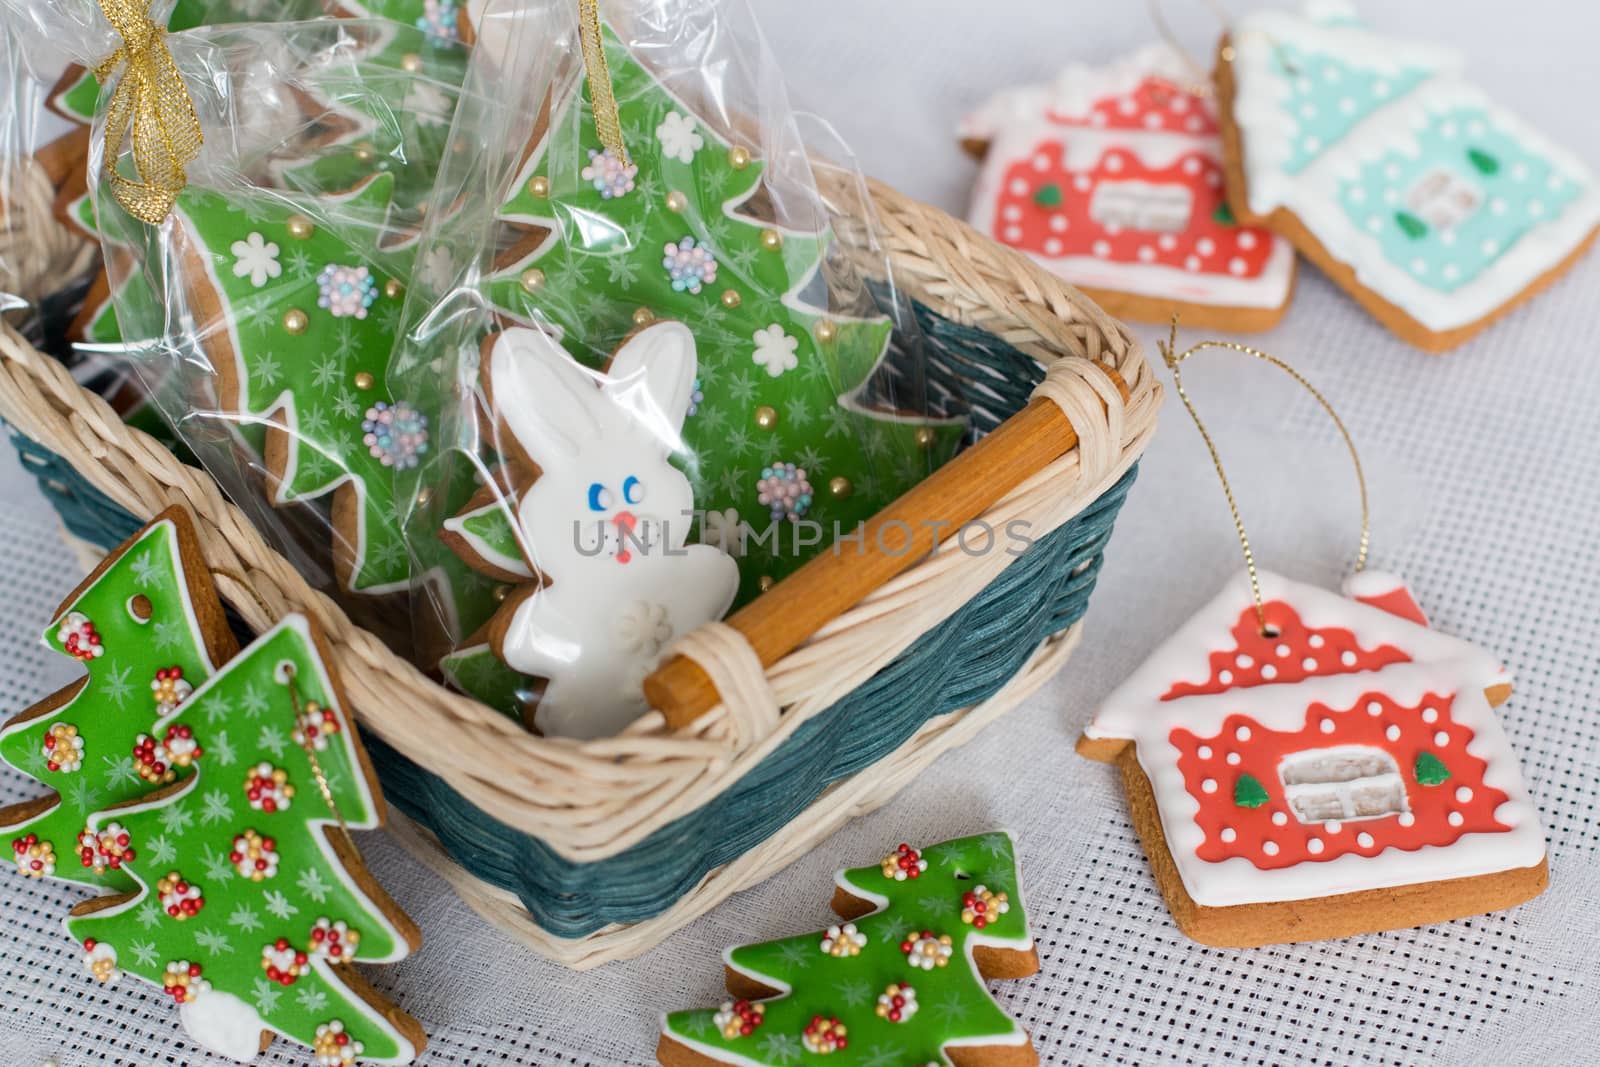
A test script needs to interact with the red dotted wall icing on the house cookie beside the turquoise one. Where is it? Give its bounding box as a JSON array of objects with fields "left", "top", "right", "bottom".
[{"left": 994, "top": 141, "right": 1274, "bottom": 278}]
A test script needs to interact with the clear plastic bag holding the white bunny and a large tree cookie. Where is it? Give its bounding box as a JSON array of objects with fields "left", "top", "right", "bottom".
[{"left": 392, "top": 0, "right": 963, "bottom": 737}]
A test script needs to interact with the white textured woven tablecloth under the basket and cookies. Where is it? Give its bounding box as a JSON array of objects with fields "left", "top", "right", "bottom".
[{"left": 0, "top": 0, "right": 1600, "bottom": 1067}]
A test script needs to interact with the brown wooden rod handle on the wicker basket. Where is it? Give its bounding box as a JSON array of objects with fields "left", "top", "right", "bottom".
[{"left": 645, "top": 363, "right": 1130, "bottom": 729}]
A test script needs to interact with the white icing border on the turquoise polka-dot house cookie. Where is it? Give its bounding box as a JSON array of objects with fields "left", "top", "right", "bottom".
[{"left": 1232, "top": 11, "right": 1600, "bottom": 333}]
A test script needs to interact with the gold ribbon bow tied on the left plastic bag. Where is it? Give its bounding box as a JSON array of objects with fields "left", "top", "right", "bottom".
[{"left": 94, "top": 0, "right": 205, "bottom": 226}]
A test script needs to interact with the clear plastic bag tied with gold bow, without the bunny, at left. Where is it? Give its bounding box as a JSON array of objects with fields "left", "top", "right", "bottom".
[{"left": 3, "top": 0, "right": 466, "bottom": 651}]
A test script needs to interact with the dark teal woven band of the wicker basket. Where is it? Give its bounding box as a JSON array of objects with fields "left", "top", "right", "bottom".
[{"left": 13, "top": 306, "right": 1136, "bottom": 937}]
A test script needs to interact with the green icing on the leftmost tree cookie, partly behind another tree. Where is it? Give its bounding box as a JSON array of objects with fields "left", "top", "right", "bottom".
[{"left": 0, "top": 520, "right": 226, "bottom": 893}]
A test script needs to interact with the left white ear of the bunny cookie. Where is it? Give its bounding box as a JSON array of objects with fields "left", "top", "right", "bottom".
[{"left": 488, "top": 326, "right": 600, "bottom": 470}]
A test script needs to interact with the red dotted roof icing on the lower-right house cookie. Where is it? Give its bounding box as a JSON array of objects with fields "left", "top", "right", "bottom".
[{"left": 1162, "top": 600, "right": 1411, "bottom": 701}]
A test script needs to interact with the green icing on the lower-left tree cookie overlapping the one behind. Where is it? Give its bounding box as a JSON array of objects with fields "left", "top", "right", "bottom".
[{"left": 67, "top": 616, "right": 408, "bottom": 1061}]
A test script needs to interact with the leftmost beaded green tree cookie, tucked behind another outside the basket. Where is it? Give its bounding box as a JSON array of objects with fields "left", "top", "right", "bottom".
[{"left": 0, "top": 509, "right": 240, "bottom": 893}]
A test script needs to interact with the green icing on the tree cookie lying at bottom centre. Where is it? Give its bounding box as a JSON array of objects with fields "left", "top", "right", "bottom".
[{"left": 664, "top": 832, "right": 1032, "bottom": 1067}]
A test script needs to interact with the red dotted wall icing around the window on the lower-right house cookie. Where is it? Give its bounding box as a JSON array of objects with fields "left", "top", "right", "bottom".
[{"left": 1170, "top": 693, "right": 1509, "bottom": 870}]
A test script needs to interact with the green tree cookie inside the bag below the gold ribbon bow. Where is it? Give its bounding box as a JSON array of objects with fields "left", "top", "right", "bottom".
[{"left": 171, "top": 174, "right": 429, "bottom": 593}]
